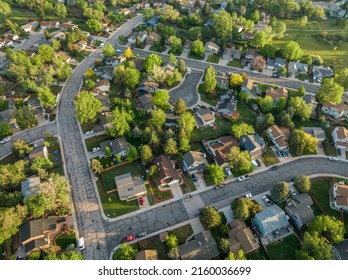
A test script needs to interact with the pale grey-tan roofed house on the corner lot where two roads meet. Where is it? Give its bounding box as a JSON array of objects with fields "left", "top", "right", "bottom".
[{"left": 115, "top": 172, "right": 146, "bottom": 201}]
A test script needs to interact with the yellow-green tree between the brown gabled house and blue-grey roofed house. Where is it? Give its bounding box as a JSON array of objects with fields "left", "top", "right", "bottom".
[{"left": 226, "top": 147, "right": 254, "bottom": 174}]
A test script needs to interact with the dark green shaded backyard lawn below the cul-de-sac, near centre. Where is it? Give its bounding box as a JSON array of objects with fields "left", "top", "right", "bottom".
[{"left": 191, "top": 117, "right": 231, "bottom": 142}]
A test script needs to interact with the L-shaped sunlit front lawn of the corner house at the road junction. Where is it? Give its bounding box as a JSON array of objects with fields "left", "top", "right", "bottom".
[{"left": 97, "top": 177, "right": 139, "bottom": 218}]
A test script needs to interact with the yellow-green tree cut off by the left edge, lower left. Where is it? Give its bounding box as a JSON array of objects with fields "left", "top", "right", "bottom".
[{"left": 0, "top": 207, "right": 22, "bottom": 245}]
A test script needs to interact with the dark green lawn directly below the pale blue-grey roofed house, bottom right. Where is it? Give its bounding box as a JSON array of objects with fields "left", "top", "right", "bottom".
[{"left": 266, "top": 234, "right": 300, "bottom": 260}]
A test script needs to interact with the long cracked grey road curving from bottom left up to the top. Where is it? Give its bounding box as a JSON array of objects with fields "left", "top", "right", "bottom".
[{"left": 57, "top": 15, "right": 142, "bottom": 259}]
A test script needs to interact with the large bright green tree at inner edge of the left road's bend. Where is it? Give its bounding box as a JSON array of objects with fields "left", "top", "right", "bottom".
[{"left": 74, "top": 90, "right": 103, "bottom": 124}]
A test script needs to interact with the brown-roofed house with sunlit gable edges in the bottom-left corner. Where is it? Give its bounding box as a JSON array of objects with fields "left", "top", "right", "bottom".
[{"left": 19, "top": 216, "right": 57, "bottom": 255}]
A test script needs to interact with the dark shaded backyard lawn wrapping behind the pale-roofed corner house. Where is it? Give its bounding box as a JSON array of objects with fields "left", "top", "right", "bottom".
[{"left": 101, "top": 161, "right": 145, "bottom": 190}]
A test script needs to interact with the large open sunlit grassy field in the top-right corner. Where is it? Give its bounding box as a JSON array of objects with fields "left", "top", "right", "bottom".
[{"left": 272, "top": 19, "right": 348, "bottom": 70}]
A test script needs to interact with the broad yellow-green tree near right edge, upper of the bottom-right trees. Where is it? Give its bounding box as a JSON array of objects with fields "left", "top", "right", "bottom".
[{"left": 308, "top": 215, "right": 345, "bottom": 244}]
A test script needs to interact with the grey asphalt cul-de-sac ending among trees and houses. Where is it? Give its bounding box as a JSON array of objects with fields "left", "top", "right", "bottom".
[{"left": 170, "top": 70, "right": 203, "bottom": 107}]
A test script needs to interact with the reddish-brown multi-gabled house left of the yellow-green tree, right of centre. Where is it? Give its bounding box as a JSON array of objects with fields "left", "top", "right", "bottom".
[{"left": 202, "top": 136, "right": 238, "bottom": 167}]
